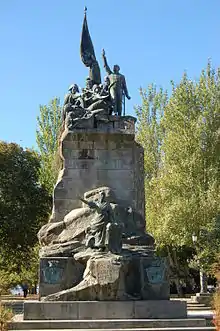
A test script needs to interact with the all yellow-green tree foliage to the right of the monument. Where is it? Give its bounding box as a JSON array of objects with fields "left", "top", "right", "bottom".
[{"left": 137, "top": 63, "right": 220, "bottom": 272}]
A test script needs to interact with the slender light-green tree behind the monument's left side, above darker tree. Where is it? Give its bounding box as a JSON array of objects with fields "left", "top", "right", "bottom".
[{"left": 36, "top": 98, "right": 62, "bottom": 194}]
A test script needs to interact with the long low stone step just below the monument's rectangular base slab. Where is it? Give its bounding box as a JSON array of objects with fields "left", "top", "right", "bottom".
[{"left": 9, "top": 318, "right": 206, "bottom": 331}]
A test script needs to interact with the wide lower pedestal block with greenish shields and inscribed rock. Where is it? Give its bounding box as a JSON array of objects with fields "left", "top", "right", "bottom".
[{"left": 39, "top": 247, "right": 170, "bottom": 301}]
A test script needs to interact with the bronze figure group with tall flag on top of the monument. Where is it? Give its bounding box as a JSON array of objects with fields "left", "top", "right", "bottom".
[{"left": 63, "top": 8, "right": 130, "bottom": 129}]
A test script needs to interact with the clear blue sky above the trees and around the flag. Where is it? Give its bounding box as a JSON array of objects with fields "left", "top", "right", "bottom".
[{"left": 0, "top": 0, "right": 220, "bottom": 147}]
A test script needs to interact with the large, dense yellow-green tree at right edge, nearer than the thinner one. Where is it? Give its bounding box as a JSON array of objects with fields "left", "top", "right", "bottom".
[{"left": 150, "top": 64, "right": 220, "bottom": 252}]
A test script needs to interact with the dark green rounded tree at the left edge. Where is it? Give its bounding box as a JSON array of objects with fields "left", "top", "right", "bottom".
[{"left": 0, "top": 142, "right": 51, "bottom": 273}]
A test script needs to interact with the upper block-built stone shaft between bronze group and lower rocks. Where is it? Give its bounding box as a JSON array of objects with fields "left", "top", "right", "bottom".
[{"left": 50, "top": 116, "right": 145, "bottom": 231}]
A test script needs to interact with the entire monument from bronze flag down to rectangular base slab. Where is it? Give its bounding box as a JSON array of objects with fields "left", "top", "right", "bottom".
[{"left": 24, "top": 7, "right": 186, "bottom": 320}]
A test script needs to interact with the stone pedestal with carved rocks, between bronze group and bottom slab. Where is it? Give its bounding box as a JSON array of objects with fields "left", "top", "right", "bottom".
[{"left": 38, "top": 116, "right": 169, "bottom": 302}]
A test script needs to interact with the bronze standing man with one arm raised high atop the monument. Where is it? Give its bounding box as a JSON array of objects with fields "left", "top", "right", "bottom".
[{"left": 102, "top": 49, "right": 131, "bottom": 116}]
